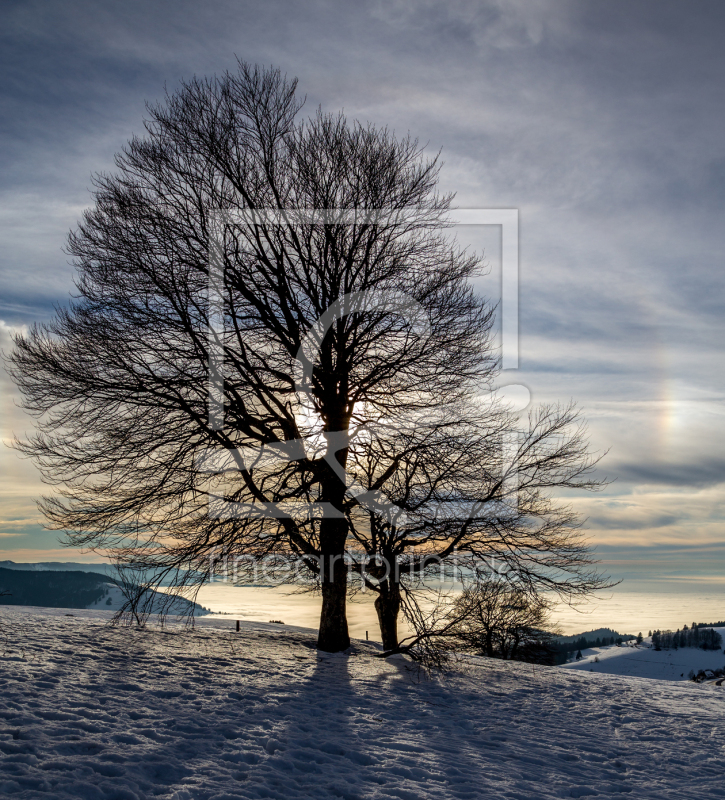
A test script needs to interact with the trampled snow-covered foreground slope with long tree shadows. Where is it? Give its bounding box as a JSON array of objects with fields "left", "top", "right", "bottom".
[{"left": 0, "top": 606, "right": 725, "bottom": 800}]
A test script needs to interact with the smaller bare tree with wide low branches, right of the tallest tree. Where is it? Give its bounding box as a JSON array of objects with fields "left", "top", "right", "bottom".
[{"left": 342, "top": 397, "right": 612, "bottom": 652}]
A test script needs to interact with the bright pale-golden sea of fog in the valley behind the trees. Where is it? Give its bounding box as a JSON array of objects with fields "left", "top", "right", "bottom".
[{"left": 197, "top": 579, "right": 725, "bottom": 640}]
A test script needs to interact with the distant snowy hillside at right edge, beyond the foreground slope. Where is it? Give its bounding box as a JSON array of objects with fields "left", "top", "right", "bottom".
[{"left": 563, "top": 628, "right": 725, "bottom": 681}]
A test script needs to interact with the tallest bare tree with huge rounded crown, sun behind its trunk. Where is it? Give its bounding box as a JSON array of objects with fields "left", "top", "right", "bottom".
[{"left": 9, "top": 63, "right": 495, "bottom": 651}]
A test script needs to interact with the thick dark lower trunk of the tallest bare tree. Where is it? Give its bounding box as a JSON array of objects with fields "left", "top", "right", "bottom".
[{"left": 317, "top": 519, "right": 350, "bottom": 653}]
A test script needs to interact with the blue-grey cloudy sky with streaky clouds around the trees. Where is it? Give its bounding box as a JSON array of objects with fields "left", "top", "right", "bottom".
[{"left": 0, "top": 0, "right": 725, "bottom": 588}]
